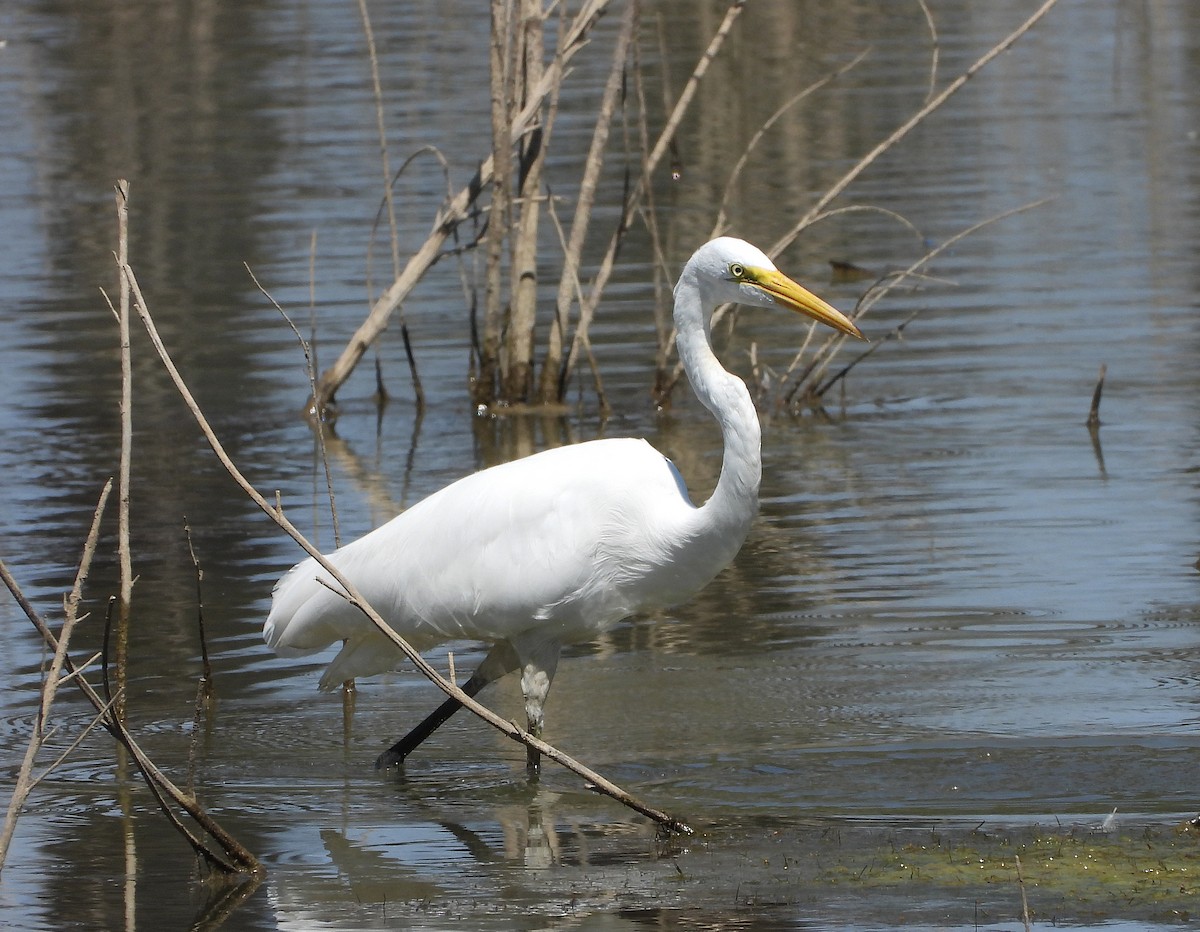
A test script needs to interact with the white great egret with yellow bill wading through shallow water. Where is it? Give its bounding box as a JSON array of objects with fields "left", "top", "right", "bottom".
[{"left": 263, "top": 236, "right": 862, "bottom": 774}]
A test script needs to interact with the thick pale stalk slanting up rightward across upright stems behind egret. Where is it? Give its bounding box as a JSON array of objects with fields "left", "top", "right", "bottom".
[{"left": 308, "top": 0, "right": 608, "bottom": 414}]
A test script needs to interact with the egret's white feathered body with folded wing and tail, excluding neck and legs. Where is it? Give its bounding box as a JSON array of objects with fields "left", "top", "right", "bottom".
[{"left": 264, "top": 440, "right": 705, "bottom": 686}]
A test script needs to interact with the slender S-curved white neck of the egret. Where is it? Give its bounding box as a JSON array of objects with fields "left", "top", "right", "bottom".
[{"left": 674, "top": 270, "right": 762, "bottom": 537}]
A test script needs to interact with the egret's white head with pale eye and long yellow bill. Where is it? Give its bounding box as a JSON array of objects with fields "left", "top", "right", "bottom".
[{"left": 685, "top": 236, "right": 863, "bottom": 339}]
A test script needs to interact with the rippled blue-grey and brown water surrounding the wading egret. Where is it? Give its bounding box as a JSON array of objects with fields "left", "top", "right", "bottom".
[{"left": 0, "top": 0, "right": 1200, "bottom": 930}]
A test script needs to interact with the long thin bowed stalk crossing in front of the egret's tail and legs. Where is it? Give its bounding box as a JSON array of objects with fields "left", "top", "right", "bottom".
[{"left": 121, "top": 265, "right": 692, "bottom": 835}]
